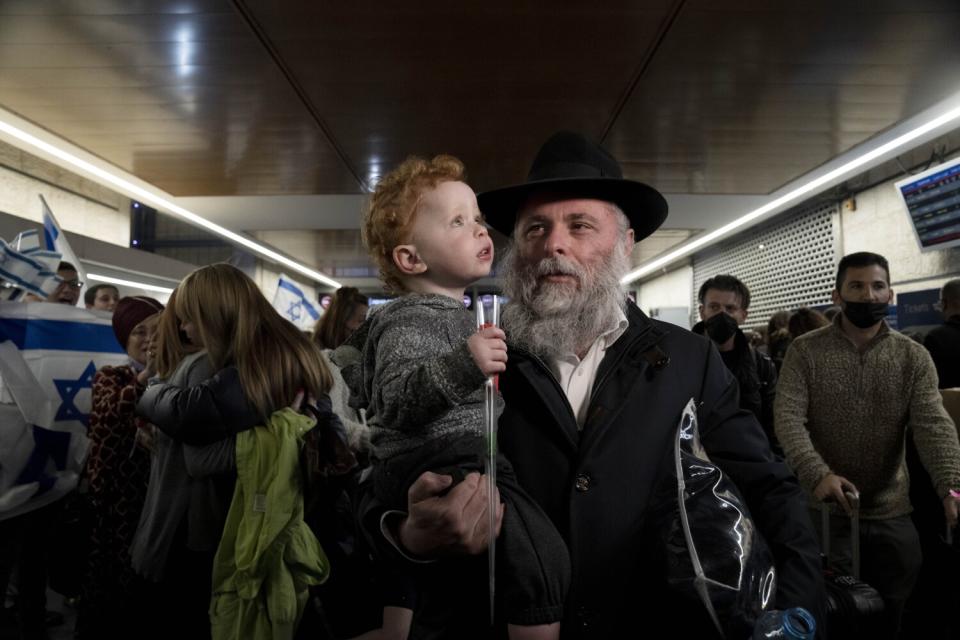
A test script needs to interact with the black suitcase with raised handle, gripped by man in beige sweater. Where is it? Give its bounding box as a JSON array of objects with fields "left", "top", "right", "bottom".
[{"left": 821, "top": 493, "right": 885, "bottom": 640}]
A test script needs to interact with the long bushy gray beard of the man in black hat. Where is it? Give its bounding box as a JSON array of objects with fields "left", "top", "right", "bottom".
[{"left": 499, "top": 243, "right": 630, "bottom": 358}]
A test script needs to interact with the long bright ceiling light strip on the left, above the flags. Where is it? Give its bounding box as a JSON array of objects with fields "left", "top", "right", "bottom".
[{"left": 0, "top": 110, "right": 340, "bottom": 289}]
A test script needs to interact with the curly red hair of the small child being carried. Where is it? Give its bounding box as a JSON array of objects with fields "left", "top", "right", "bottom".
[{"left": 363, "top": 155, "right": 466, "bottom": 293}]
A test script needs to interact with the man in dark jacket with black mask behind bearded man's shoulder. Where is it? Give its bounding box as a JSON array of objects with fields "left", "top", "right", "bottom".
[{"left": 692, "top": 275, "right": 783, "bottom": 456}]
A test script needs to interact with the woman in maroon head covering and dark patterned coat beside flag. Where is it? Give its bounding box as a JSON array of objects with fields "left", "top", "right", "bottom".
[{"left": 77, "top": 296, "right": 163, "bottom": 638}]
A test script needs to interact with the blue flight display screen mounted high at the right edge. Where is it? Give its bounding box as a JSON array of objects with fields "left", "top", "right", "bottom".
[{"left": 896, "top": 158, "right": 960, "bottom": 251}]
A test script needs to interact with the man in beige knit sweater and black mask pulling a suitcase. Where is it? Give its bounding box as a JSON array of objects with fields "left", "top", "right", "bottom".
[{"left": 775, "top": 252, "right": 960, "bottom": 637}]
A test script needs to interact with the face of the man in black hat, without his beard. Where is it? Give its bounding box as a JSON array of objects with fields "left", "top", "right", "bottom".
[{"left": 513, "top": 196, "right": 633, "bottom": 296}]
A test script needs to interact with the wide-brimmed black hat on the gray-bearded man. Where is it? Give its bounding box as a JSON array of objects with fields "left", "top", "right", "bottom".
[{"left": 477, "top": 131, "right": 667, "bottom": 241}]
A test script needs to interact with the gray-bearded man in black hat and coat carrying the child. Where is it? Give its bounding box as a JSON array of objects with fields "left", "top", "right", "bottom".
[{"left": 361, "top": 132, "right": 823, "bottom": 638}]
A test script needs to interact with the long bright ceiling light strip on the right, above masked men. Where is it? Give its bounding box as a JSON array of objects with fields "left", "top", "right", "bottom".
[{"left": 620, "top": 97, "right": 960, "bottom": 284}]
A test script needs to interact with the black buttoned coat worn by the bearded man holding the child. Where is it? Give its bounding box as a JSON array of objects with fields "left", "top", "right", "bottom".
[{"left": 498, "top": 305, "right": 823, "bottom": 638}]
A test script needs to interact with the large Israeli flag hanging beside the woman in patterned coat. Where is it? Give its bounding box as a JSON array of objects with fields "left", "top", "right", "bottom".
[{"left": 0, "top": 302, "right": 130, "bottom": 520}]
